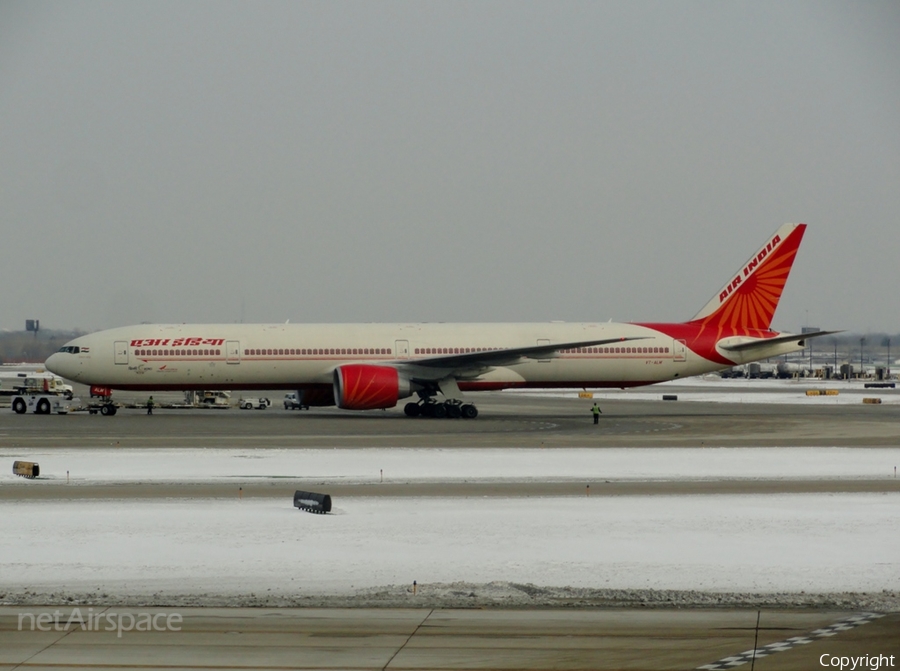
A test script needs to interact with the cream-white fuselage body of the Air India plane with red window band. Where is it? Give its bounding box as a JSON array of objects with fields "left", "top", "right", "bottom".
[{"left": 47, "top": 323, "right": 799, "bottom": 391}]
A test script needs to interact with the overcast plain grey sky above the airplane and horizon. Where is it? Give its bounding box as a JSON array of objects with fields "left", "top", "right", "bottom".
[{"left": 0, "top": 0, "right": 900, "bottom": 332}]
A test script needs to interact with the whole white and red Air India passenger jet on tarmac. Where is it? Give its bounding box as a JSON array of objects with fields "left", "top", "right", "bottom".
[{"left": 46, "top": 224, "right": 826, "bottom": 419}]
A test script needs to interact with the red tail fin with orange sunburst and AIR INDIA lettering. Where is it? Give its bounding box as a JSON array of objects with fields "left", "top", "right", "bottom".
[{"left": 691, "top": 224, "right": 806, "bottom": 330}]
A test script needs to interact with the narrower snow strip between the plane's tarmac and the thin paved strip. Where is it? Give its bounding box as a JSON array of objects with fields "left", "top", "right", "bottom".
[{"left": 0, "top": 447, "right": 900, "bottom": 487}]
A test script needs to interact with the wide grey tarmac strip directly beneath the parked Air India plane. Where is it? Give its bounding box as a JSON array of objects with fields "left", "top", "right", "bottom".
[{"left": 0, "top": 386, "right": 900, "bottom": 448}]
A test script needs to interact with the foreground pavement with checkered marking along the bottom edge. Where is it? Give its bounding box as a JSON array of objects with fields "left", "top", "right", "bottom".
[{"left": 0, "top": 607, "right": 900, "bottom": 671}]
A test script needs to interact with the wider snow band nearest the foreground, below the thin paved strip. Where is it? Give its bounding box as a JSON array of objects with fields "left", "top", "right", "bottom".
[{"left": 0, "top": 494, "right": 900, "bottom": 595}]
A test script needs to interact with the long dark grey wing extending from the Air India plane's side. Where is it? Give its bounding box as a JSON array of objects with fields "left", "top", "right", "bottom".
[{"left": 401, "top": 336, "right": 647, "bottom": 379}]
